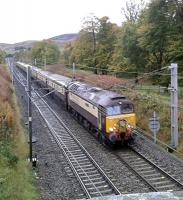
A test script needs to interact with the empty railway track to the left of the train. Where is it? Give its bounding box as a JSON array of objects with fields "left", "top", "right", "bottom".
[{"left": 13, "top": 67, "right": 121, "bottom": 198}]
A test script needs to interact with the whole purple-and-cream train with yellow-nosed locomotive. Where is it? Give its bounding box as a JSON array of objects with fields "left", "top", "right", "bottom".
[{"left": 16, "top": 62, "right": 136, "bottom": 146}]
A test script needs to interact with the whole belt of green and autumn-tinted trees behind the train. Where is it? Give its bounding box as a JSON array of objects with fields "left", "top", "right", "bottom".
[{"left": 15, "top": 0, "right": 183, "bottom": 87}]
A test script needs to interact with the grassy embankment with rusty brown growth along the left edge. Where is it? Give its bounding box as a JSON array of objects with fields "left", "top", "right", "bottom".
[{"left": 0, "top": 65, "right": 37, "bottom": 200}]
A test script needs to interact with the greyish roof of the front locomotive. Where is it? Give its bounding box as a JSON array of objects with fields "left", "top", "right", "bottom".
[{"left": 69, "top": 82, "right": 130, "bottom": 107}]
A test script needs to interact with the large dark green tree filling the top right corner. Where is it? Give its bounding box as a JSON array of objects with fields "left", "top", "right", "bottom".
[{"left": 138, "top": 0, "right": 183, "bottom": 84}]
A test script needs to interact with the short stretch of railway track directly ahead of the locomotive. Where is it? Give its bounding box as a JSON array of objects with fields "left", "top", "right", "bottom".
[{"left": 115, "top": 146, "right": 183, "bottom": 192}]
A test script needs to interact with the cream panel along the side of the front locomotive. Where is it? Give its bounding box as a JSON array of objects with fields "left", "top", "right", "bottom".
[{"left": 69, "top": 93, "right": 98, "bottom": 118}]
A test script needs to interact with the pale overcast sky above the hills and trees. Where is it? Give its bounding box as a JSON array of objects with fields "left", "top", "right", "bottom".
[{"left": 0, "top": 0, "right": 145, "bottom": 43}]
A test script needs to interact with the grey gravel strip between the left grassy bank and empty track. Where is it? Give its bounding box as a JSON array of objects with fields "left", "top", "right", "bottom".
[{"left": 16, "top": 77, "right": 84, "bottom": 200}]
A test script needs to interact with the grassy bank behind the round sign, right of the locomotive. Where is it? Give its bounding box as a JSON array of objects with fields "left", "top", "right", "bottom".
[{"left": 124, "top": 86, "right": 183, "bottom": 153}]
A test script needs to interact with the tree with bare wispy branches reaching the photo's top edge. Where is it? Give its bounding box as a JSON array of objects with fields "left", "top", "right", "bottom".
[{"left": 120, "top": 0, "right": 146, "bottom": 75}]
